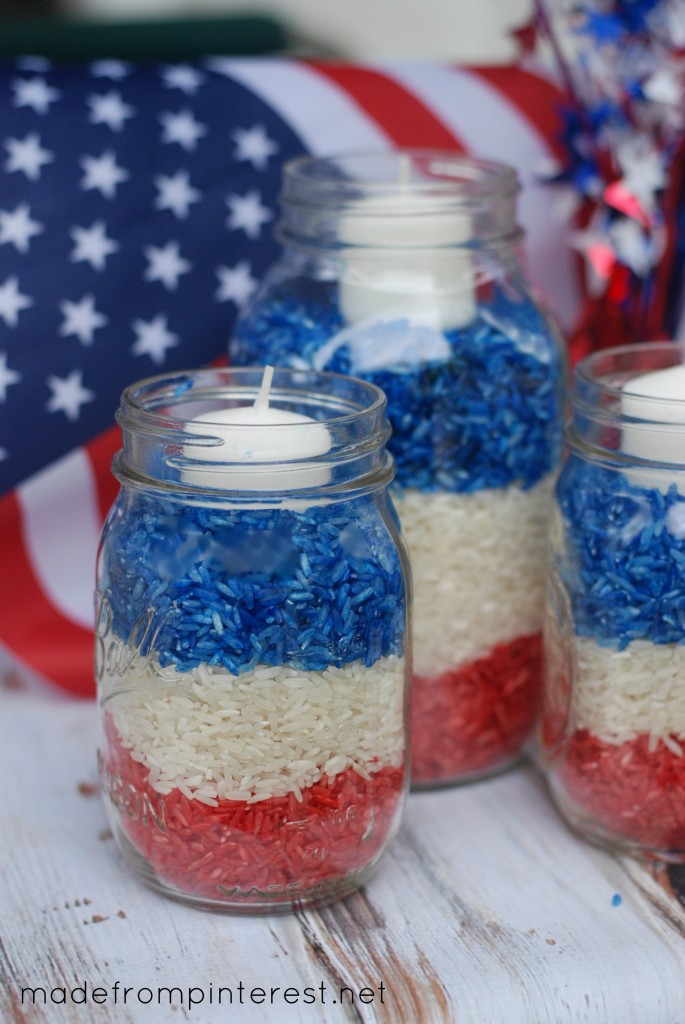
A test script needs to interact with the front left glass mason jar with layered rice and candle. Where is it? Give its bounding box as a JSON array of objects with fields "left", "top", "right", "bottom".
[{"left": 95, "top": 370, "right": 411, "bottom": 911}]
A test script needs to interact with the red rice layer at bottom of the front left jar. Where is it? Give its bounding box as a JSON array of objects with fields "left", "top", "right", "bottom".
[{"left": 101, "top": 716, "right": 404, "bottom": 903}]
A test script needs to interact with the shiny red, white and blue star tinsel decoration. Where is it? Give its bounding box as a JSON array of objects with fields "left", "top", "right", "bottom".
[{"left": 519, "top": 0, "right": 685, "bottom": 357}]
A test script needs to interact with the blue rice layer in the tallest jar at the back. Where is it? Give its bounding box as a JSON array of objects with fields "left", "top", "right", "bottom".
[{"left": 230, "top": 282, "right": 563, "bottom": 493}]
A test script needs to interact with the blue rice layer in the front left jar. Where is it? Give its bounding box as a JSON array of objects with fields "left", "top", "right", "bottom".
[{"left": 99, "top": 495, "right": 405, "bottom": 675}]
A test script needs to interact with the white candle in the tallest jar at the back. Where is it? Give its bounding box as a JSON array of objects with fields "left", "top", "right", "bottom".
[{"left": 340, "top": 181, "right": 476, "bottom": 331}]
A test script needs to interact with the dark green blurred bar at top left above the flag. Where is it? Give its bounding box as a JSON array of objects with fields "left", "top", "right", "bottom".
[{"left": 0, "top": 15, "right": 290, "bottom": 61}]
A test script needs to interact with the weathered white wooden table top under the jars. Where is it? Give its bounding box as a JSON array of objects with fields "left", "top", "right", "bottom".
[{"left": 0, "top": 691, "right": 685, "bottom": 1024}]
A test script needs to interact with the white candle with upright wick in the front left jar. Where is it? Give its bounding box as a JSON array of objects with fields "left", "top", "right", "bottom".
[{"left": 181, "top": 367, "right": 331, "bottom": 492}]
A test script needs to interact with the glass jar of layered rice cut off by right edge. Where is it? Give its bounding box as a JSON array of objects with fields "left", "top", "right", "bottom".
[{"left": 540, "top": 342, "right": 685, "bottom": 861}]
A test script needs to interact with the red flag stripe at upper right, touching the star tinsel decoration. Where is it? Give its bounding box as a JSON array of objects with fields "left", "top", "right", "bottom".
[{"left": 468, "top": 67, "right": 568, "bottom": 160}]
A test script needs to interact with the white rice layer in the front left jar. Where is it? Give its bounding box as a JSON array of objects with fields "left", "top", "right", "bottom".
[{"left": 102, "top": 655, "right": 404, "bottom": 805}]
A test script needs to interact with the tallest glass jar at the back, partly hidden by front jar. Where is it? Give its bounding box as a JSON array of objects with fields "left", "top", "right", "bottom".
[{"left": 229, "top": 151, "right": 566, "bottom": 787}]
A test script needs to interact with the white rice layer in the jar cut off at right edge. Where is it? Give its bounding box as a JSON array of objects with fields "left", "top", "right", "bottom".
[{"left": 571, "top": 637, "right": 685, "bottom": 755}]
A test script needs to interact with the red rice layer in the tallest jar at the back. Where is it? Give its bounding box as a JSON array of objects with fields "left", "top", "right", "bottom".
[{"left": 412, "top": 635, "right": 541, "bottom": 784}]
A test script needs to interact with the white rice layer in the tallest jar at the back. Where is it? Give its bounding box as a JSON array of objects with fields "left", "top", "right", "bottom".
[{"left": 395, "top": 476, "right": 553, "bottom": 676}]
